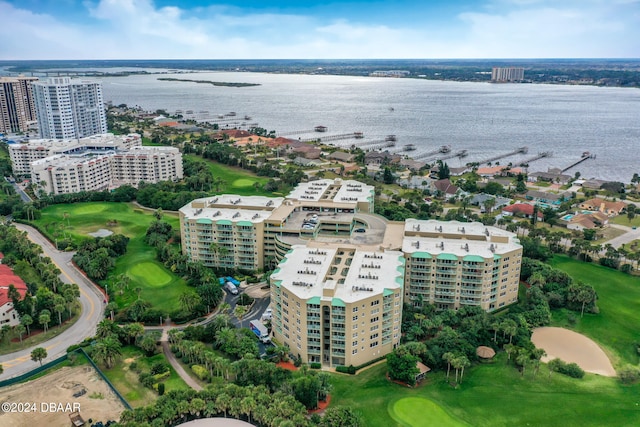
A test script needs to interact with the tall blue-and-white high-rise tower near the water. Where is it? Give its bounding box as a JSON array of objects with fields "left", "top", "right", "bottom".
[{"left": 33, "top": 77, "right": 107, "bottom": 139}]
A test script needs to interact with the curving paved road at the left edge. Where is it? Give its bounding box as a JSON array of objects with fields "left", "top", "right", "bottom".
[{"left": 0, "top": 224, "right": 104, "bottom": 379}]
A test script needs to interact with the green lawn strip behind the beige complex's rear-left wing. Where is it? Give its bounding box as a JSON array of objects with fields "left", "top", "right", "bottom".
[{"left": 185, "top": 155, "right": 273, "bottom": 196}]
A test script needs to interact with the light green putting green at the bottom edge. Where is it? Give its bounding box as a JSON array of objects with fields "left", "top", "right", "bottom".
[{"left": 389, "top": 397, "right": 467, "bottom": 427}]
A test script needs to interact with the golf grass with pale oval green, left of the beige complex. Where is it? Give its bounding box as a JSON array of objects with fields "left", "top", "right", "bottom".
[{"left": 36, "top": 202, "right": 187, "bottom": 312}]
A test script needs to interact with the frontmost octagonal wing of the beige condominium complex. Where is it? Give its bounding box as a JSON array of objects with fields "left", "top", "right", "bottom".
[{"left": 271, "top": 246, "right": 404, "bottom": 366}]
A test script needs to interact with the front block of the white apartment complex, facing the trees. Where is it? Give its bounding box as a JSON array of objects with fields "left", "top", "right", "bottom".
[{"left": 31, "top": 147, "right": 183, "bottom": 194}]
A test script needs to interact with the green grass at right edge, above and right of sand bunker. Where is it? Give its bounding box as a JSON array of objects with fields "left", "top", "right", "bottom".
[{"left": 551, "top": 256, "right": 640, "bottom": 369}]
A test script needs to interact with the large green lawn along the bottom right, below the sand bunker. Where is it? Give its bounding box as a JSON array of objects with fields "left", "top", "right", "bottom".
[{"left": 331, "top": 354, "right": 640, "bottom": 427}]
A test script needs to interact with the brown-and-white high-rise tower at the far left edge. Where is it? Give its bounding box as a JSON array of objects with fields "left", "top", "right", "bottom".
[{"left": 0, "top": 76, "right": 38, "bottom": 133}]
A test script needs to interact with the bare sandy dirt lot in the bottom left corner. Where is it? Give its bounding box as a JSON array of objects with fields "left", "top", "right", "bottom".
[{"left": 0, "top": 366, "right": 125, "bottom": 427}]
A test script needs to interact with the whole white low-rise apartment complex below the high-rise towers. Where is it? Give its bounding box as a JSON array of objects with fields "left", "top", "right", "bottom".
[{"left": 9, "top": 134, "right": 183, "bottom": 194}]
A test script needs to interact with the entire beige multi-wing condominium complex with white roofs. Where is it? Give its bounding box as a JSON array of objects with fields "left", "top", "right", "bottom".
[{"left": 180, "top": 179, "right": 522, "bottom": 366}]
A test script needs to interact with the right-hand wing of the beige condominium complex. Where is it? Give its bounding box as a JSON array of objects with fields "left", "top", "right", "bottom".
[{"left": 402, "top": 219, "right": 522, "bottom": 311}]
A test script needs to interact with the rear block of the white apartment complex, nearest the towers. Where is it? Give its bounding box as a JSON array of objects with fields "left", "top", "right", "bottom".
[{"left": 9, "top": 133, "right": 142, "bottom": 175}]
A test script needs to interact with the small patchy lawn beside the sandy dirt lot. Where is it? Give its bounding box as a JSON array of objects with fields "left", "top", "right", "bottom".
[{"left": 102, "top": 346, "right": 189, "bottom": 408}]
